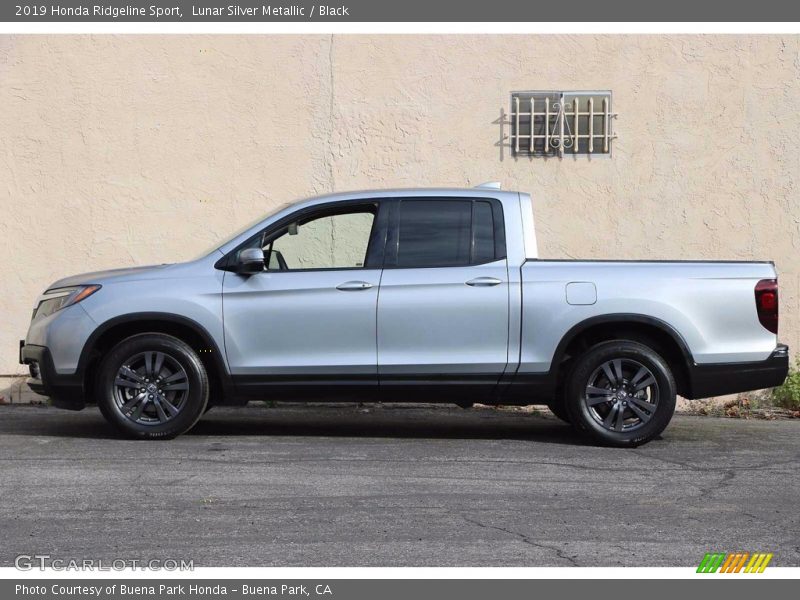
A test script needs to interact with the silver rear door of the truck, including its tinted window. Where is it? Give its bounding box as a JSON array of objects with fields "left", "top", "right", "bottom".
[{"left": 377, "top": 198, "right": 509, "bottom": 393}]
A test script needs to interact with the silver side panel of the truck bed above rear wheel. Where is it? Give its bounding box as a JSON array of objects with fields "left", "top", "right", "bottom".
[{"left": 520, "top": 259, "right": 776, "bottom": 373}]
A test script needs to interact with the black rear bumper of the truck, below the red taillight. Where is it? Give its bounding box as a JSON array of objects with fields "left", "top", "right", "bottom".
[{"left": 686, "top": 344, "right": 789, "bottom": 399}]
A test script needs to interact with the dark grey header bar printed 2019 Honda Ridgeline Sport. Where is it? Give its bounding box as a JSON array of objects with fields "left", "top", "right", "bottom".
[{"left": 0, "top": 0, "right": 800, "bottom": 23}]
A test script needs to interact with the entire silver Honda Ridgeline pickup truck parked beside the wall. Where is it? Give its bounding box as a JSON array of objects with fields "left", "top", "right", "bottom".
[{"left": 20, "top": 185, "right": 788, "bottom": 446}]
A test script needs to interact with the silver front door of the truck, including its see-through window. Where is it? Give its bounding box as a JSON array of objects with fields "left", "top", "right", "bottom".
[{"left": 223, "top": 203, "right": 383, "bottom": 397}]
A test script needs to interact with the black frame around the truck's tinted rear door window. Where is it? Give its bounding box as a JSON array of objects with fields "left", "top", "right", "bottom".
[{"left": 383, "top": 196, "right": 506, "bottom": 269}]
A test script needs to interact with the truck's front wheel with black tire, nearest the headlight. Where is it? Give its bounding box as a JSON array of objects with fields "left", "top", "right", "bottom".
[{"left": 95, "top": 333, "right": 209, "bottom": 439}]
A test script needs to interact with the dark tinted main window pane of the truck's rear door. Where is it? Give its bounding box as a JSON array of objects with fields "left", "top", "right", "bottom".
[{"left": 397, "top": 200, "right": 472, "bottom": 267}]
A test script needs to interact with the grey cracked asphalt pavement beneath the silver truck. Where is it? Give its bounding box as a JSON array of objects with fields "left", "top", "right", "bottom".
[{"left": 0, "top": 405, "right": 800, "bottom": 566}]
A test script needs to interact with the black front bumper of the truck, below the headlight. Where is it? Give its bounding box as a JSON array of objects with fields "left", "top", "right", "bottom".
[{"left": 19, "top": 340, "right": 86, "bottom": 410}]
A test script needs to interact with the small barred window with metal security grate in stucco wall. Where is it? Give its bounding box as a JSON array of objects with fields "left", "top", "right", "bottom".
[{"left": 510, "top": 91, "right": 617, "bottom": 156}]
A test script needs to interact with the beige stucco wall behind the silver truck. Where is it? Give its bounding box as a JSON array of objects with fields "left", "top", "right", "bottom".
[{"left": 0, "top": 35, "right": 800, "bottom": 374}]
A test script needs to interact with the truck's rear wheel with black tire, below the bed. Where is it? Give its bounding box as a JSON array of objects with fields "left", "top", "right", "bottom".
[{"left": 565, "top": 341, "right": 676, "bottom": 447}]
